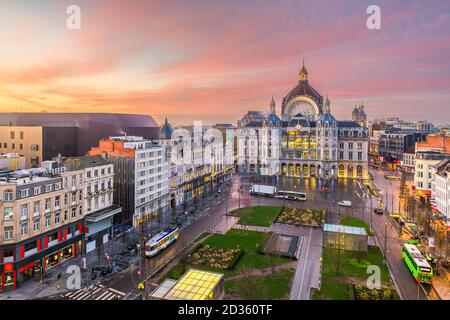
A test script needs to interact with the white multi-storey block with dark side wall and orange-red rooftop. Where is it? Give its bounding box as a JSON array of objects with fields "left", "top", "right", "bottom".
[{"left": 89, "top": 136, "right": 170, "bottom": 227}]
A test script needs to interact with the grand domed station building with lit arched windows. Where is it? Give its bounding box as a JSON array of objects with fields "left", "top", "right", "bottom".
[{"left": 237, "top": 64, "right": 368, "bottom": 179}]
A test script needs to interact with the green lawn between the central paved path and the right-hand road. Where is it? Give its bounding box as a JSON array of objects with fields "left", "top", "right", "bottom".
[{"left": 313, "top": 246, "right": 389, "bottom": 300}]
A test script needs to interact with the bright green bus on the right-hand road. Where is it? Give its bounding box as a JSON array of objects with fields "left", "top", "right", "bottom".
[{"left": 402, "top": 243, "right": 433, "bottom": 283}]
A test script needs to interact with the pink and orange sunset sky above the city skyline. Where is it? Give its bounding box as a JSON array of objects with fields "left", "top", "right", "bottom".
[{"left": 0, "top": 0, "right": 450, "bottom": 124}]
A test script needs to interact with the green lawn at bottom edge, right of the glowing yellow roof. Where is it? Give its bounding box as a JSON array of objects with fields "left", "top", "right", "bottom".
[{"left": 225, "top": 270, "right": 294, "bottom": 300}]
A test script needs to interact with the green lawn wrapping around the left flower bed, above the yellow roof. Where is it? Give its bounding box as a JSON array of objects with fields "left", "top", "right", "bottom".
[{"left": 163, "top": 229, "right": 291, "bottom": 279}]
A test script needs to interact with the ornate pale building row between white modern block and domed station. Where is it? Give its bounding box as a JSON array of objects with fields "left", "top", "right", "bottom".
[{"left": 158, "top": 119, "right": 234, "bottom": 210}]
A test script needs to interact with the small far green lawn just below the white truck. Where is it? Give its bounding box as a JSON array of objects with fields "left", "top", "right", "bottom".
[{"left": 230, "top": 206, "right": 281, "bottom": 227}]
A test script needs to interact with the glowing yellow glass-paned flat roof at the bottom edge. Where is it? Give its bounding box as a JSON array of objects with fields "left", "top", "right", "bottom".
[{"left": 163, "top": 269, "right": 223, "bottom": 300}]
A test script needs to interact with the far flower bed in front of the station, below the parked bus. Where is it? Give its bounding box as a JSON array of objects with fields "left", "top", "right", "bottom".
[{"left": 277, "top": 208, "right": 324, "bottom": 227}]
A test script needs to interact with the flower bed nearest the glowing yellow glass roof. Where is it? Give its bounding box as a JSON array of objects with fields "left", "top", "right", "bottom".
[{"left": 190, "top": 245, "right": 242, "bottom": 270}]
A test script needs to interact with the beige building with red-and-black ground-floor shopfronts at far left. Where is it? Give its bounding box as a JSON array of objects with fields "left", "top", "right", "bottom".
[{"left": 0, "top": 168, "right": 84, "bottom": 291}]
